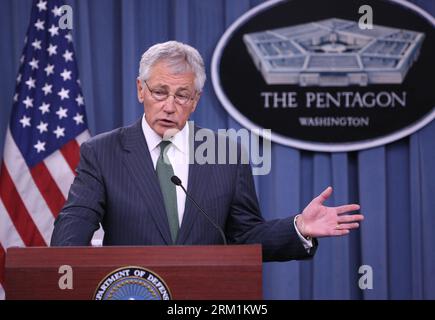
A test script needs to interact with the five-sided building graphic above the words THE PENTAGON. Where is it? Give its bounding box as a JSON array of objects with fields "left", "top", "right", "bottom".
[{"left": 243, "top": 18, "right": 424, "bottom": 86}]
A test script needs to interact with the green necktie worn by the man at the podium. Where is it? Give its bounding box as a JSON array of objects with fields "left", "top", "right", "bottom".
[{"left": 156, "top": 140, "right": 179, "bottom": 243}]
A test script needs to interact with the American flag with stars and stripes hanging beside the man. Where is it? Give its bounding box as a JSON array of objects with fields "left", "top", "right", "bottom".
[{"left": 0, "top": 0, "right": 89, "bottom": 299}]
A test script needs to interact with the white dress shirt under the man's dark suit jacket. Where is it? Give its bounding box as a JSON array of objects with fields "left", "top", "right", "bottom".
[{"left": 142, "top": 115, "right": 189, "bottom": 226}]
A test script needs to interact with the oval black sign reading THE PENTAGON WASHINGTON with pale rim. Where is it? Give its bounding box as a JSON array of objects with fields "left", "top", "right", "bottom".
[{"left": 212, "top": 0, "right": 435, "bottom": 152}]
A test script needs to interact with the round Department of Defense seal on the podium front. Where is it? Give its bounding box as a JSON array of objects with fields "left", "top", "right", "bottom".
[{"left": 94, "top": 266, "right": 171, "bottom": 300}]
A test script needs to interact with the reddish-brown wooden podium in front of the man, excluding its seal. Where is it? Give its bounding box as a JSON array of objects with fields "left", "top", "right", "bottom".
[{"left": 5, "top": 245, "right": 262, "bottom": 300}]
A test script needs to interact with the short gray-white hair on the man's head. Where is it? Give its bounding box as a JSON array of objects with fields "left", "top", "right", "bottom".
[{"left": 137, "top": 41, "right": 206, "bottom": 92}]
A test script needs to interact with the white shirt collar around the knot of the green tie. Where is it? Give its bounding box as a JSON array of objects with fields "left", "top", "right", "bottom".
[{"left": 142, "top": 114, "right": 189, "bottom": 154}]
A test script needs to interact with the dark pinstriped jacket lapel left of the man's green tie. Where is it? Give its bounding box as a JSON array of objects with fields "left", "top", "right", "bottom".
[{"left": 122, "top": 118, "right": 172, "bottom": 244}]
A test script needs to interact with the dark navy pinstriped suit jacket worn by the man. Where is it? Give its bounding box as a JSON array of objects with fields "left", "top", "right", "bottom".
[{"left": 51, "top": 119, "right": 315, "bottom": 261}]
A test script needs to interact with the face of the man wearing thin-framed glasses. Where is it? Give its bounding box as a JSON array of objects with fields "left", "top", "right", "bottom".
[{"left": 137, "top": 61, "right": 199, "bottom": 137}]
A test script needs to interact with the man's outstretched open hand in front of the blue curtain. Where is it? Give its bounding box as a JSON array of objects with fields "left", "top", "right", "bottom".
[{"left": 296, "top": 187, "right": 364, "bottom": 238}]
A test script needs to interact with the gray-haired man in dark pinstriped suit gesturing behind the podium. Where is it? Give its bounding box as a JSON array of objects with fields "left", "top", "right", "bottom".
[{"left": 51, "top": 41, "right": 363, "bottom": 261}]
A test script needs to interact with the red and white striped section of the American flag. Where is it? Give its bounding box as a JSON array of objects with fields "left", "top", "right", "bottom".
[{"left": 0, "top": 129, "right": 90, "bottom": 299}]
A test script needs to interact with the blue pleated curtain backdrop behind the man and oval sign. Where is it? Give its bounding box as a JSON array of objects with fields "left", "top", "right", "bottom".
[{"left": 0, "top": 0, "right": 435, "bottom": 299}]
